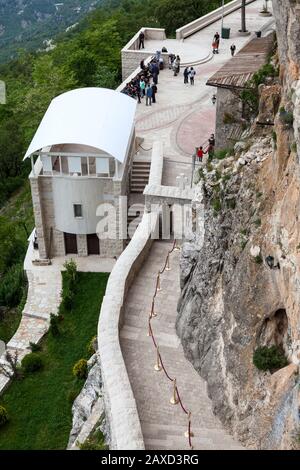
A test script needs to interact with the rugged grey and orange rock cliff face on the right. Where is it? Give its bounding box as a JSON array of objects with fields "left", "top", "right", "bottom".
[{"left": 177, "top": 0, "right": 300, "bottom": 449}]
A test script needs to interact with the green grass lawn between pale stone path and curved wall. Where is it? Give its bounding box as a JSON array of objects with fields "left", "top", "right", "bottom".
[{"left": 0, "top": 273, "right": 108, "bottom": 450}]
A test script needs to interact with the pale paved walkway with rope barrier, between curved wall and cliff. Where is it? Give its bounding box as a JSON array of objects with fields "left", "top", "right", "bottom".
[{"left": 120, "top": 241, "right": 241, "bottom": 450}]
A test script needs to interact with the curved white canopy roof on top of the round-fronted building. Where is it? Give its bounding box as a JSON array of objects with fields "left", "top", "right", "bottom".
[{"left": 24, "top": 88, "right": 136, "bottom": 163}]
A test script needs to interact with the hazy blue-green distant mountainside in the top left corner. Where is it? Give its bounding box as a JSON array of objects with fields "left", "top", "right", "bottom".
[{"left": 0, "top": 0, "right": 102, "bottom": 62}]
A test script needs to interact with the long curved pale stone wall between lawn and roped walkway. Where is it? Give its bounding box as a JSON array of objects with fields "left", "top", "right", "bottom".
[{"left": 98, "top": 212, "right": 159, "bottom": 450}]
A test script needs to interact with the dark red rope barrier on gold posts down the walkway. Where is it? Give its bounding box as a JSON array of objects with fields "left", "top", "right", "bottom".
[{"left": 148, "top": 240, "right": 194, "bottom": 449}]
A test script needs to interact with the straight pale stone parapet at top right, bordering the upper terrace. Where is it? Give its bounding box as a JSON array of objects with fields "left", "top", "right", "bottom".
[{"left": 176, "top": 0, "right": 256, "bottom": 39}]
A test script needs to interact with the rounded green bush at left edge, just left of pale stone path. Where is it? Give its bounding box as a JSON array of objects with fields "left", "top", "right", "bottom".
[{"left": 0, "top": 264, "right": 26, "bottom": 308}]
